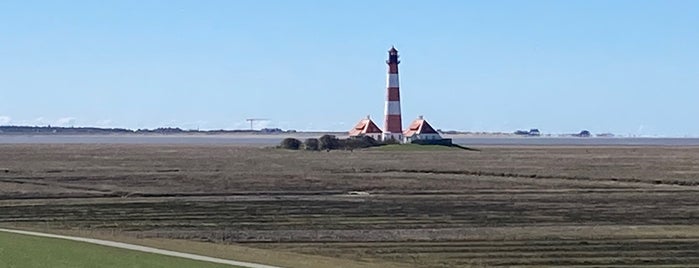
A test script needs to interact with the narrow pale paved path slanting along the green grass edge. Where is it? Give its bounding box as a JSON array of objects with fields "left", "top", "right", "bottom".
[{"left": 0, "top": 228, "right": 281, "bottom": 268}]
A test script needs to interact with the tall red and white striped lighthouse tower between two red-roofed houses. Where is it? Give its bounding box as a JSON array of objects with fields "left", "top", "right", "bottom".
[{"left": 383, "top": 47, "right": 403, "bottom": 142}]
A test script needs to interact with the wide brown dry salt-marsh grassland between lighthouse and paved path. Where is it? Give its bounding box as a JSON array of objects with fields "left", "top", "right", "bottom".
[{"left": 0, "top": 145, "right": 699, "bottom": 267}]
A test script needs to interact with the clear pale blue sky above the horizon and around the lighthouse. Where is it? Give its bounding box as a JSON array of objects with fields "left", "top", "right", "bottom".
[{"left": 0, "top": 0, "right": 699, "bottom": 136}]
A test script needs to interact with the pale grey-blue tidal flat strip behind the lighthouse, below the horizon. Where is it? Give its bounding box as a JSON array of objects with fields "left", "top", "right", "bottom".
[{"left": 0, "top": 132, "right": 699, "bottom": 146}]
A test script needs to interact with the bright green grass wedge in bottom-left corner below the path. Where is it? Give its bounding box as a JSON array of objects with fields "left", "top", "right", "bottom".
[{"left": 0, "top": 233, "right": 232, "bottom": 268}]
